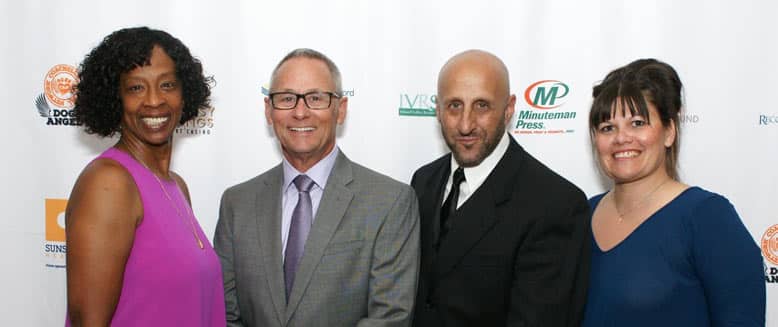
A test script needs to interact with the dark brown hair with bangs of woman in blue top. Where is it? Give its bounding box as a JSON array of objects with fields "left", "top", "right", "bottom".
[{"left": 589, "top": 59, "right": 683, "bottom": 180}]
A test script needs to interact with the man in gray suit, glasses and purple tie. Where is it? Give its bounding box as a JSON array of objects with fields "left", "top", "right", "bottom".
[{"left": 214, "top": 49, "right": 419, "bottom": 326}]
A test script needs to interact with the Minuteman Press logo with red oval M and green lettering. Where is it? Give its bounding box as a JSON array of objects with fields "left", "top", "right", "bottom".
[{"left": 513, "top": 79, "right": 577, "bottom": 134}]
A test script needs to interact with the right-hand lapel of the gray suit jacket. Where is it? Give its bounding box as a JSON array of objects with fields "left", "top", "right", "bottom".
[{"left": 280, "top": 152, "right": 354, "bottom": 325}]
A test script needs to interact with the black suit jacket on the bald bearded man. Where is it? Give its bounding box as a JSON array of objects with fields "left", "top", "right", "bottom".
[{"left": 411, "top": 137, "right": 591, "bottom": 327}]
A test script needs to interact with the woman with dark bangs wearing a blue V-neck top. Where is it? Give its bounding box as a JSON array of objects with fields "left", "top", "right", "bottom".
[{"left": 583, "top": 59, "right": 765, "bottom": 327}]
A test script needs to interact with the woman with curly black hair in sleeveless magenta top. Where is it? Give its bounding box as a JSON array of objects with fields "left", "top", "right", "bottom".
[{"left": 66, "top": 27, "right": 226, "bottom": 326}]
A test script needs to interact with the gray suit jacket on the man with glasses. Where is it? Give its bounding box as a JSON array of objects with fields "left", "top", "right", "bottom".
[{"left": 214, "top": 152, "right": 419, "bottom": 326}]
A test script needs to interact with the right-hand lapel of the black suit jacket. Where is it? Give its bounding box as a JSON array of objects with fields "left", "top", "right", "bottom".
[{"left": 437, "top": 137, "right": 523, "bottom": 275}]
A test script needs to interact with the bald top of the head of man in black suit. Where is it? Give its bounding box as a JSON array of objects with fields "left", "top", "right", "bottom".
[{"left": 438, "top": 50, "right": 510, "bottom": 97}]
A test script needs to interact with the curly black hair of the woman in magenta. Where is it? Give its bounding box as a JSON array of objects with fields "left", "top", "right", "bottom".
[{"left": 73, "top": 27, "right": 213, "bottom": 137}]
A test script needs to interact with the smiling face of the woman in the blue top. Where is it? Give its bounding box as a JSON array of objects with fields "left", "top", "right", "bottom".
[{"left": 593, "top": 101, "right": 676, "bottom": 184}]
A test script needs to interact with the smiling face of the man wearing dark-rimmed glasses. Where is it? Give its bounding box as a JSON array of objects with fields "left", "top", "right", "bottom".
[{"left": 265, "top": 57, "right": 348, "bottom": 172}]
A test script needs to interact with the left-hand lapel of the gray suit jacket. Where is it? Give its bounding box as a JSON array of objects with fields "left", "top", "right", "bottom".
[{"left": 256, "top": 165, "right": 286, "bottom": 322}]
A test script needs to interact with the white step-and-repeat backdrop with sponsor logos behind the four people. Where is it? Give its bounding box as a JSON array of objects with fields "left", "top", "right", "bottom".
[{"left": 0, "top": 0, "right": 778, "bottom": 326}]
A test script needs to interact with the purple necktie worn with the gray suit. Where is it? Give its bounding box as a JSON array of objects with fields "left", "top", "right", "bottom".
[{"left": 284, "top": 175, "right": 315, "bottom": 302}]
